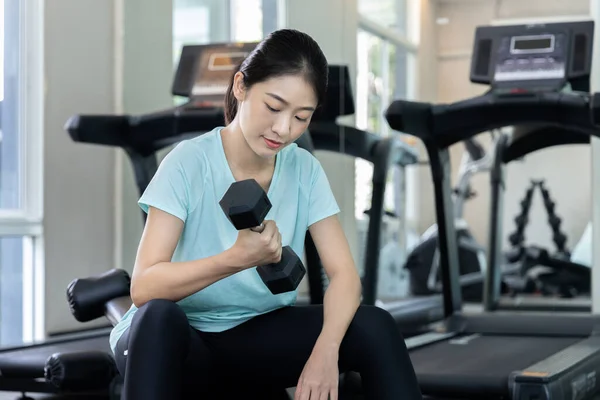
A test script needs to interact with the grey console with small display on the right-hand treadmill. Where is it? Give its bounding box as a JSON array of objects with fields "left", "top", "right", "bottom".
[{"left": 471, "top": 21, "right": 594, "bottom": 91}]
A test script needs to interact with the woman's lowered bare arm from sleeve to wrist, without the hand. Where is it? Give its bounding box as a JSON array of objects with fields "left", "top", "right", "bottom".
[{"left": 309, "top": 215, "right": 362, "bottom": 350}]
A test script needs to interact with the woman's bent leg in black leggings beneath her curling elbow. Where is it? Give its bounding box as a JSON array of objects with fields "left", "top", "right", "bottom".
[{"left": 115, "top": 300, "right": 214, "bottom": 398}]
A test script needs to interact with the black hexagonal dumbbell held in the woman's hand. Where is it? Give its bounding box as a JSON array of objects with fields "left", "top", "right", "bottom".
[{"left": 219, "top": 179, "right": 306, "bottom": 294}]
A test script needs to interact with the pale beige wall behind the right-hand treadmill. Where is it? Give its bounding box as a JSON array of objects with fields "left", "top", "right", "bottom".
[{"left": 420, "top": 0, "right": 591, "bottom": 250}]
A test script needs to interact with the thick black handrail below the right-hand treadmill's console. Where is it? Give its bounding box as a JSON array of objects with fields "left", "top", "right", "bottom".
[{"left": 385, "top": 92, "right": 600, "bottom": 148}]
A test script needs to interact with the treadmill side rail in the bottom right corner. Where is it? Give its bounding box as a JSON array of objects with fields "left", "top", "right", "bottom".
[{"left": 509, "top": 336, "right": 600, "bottom": 400}]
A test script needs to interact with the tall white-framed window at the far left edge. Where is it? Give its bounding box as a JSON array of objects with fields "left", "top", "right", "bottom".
[{"left": 0, "top": 0, "right": 44, "bottom": 346}]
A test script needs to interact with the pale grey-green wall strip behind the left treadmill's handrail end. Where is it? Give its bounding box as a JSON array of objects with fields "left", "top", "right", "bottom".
[{"left": 116, "top": 0, "right": 174, "bottom": 273}]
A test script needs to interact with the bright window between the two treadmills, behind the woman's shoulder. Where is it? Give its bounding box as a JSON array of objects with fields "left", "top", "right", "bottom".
[{"left": 355, "top": 0, "right": 417, "bottom": 298}]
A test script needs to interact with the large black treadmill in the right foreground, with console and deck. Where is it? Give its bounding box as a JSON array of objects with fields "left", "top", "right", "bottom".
[{"left": 386, "top": 21, "right": 600, "bottom": 400}]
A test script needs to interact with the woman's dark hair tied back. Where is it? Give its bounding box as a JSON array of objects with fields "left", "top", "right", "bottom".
[{"left": 225, "top": 29, "right": 329, "bottom": 124}]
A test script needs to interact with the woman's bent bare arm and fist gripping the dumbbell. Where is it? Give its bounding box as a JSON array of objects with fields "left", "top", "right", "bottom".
[{"left": 131, "top": 207, "right": 281, "bottom": 307}]
